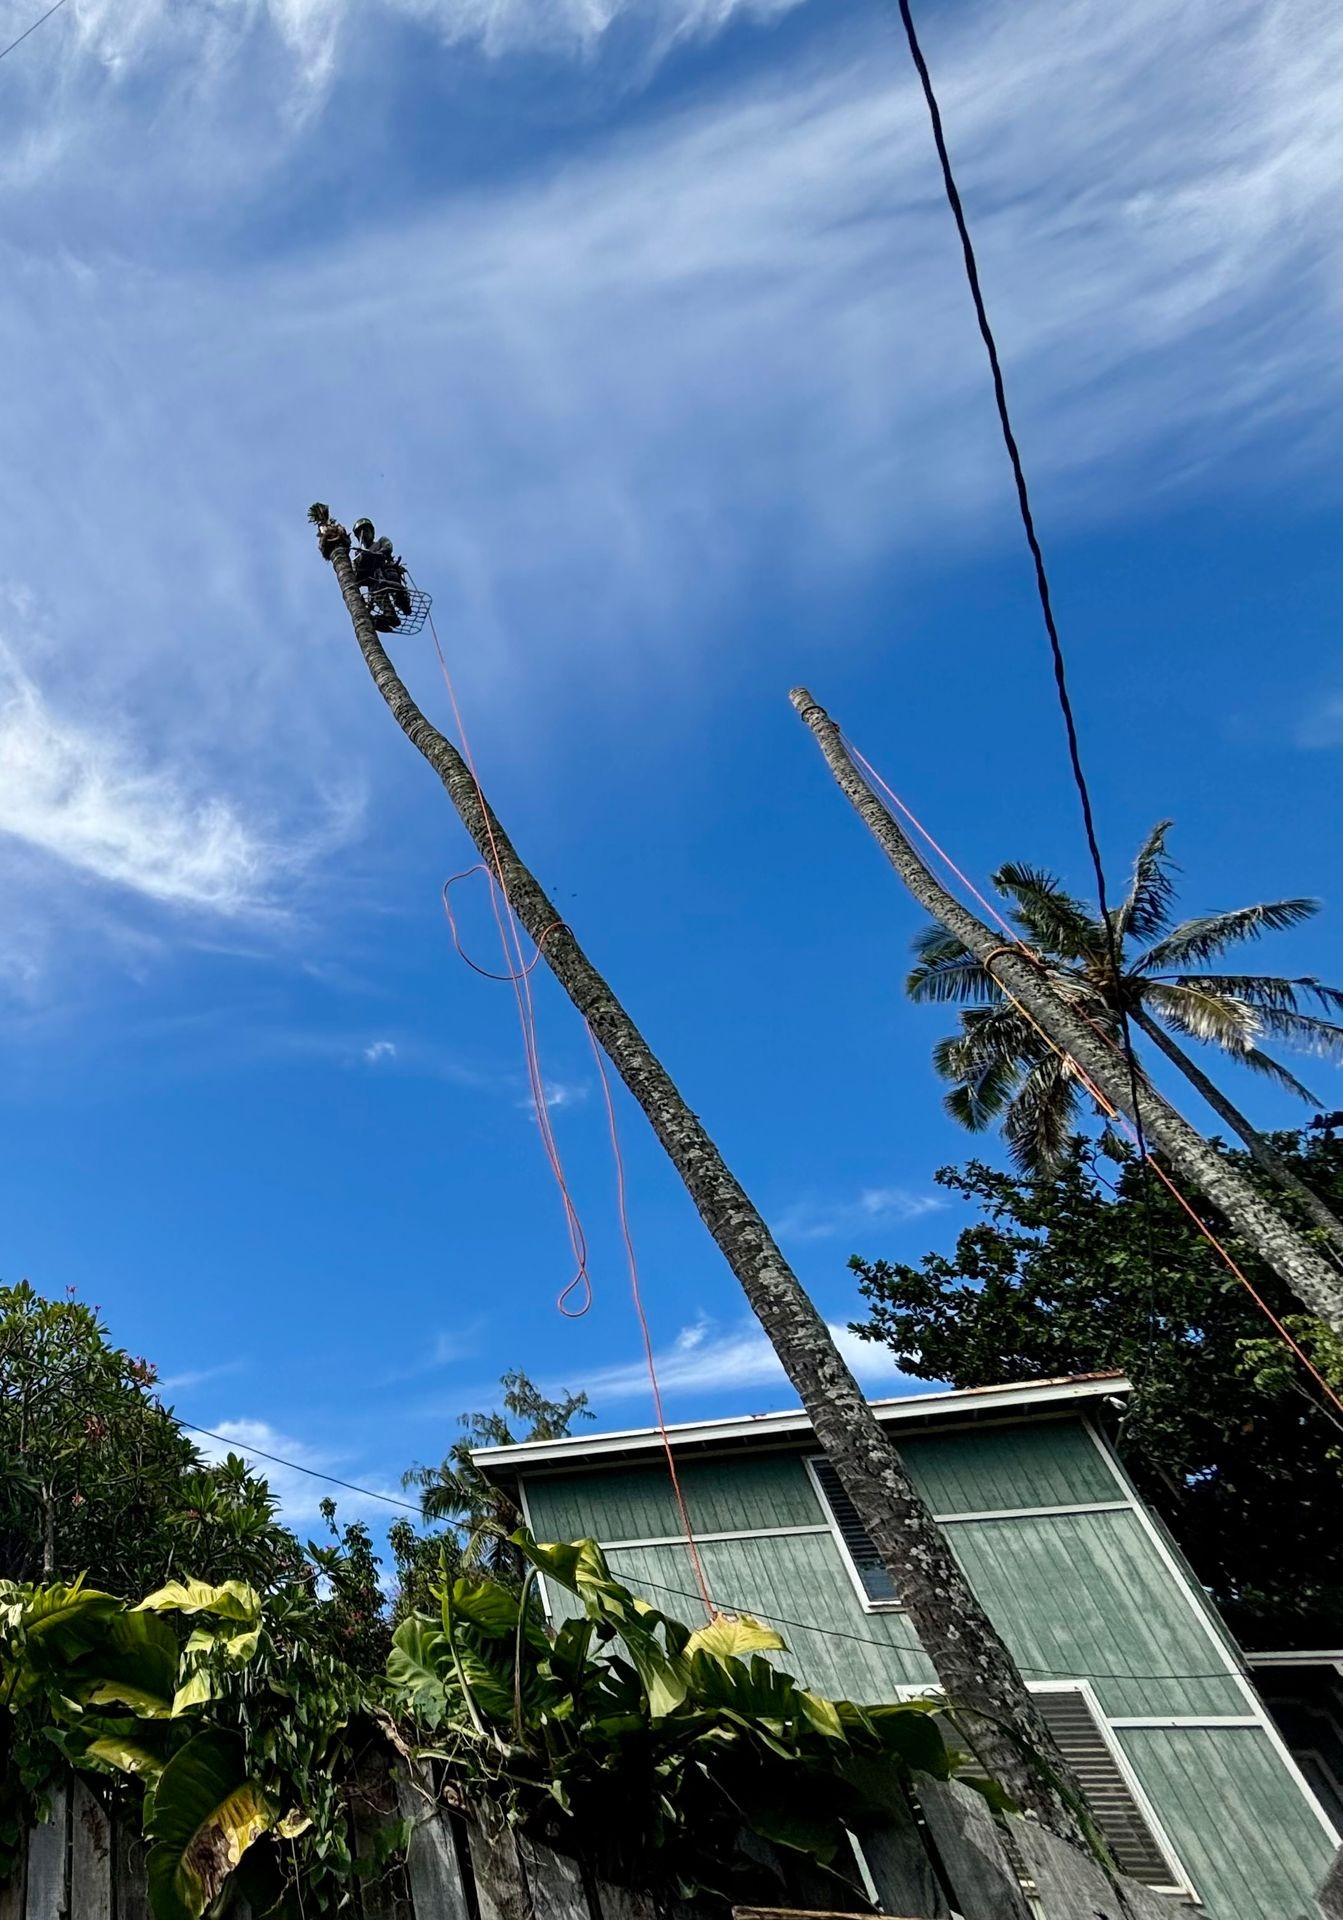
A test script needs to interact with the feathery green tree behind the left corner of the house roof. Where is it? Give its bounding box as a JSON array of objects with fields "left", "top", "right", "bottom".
[{"left": 388, "top": 1369, "right": 592, "bottom": 1619}]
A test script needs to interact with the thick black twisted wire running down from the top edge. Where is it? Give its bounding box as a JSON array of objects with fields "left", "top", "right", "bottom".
[{"left": 899, "top": 0, "right": 1157, "bottom": 1413}]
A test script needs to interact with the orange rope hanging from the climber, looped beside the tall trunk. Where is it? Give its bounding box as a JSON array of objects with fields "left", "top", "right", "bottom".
[{"left": 428, "top": 614, "right": 719, "bottom": 1620}]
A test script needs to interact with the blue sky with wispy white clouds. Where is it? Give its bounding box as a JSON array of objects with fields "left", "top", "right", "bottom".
[{"left": 0, "top": 0, "right": 1343, "bottom": 1523}]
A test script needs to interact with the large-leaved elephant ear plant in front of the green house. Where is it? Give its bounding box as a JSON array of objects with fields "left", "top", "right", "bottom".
[{"left": 388, "top": 1532, "right": 988, "bottom": 1907}]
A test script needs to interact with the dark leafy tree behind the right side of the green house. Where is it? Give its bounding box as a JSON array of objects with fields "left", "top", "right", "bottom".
[{"left": 851, "top": 1129, "right": 1343, "bottom": 1647}]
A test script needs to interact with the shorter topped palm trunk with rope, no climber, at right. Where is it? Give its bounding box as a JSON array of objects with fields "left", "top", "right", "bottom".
[{"left": 790, "top": 687, "right": 1343, "bottom": 1332}]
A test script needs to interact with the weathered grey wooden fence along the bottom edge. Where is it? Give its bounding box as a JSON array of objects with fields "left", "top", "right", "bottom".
[{"left": 0, "top": 1774, "right": 1343, "bottom": 1920}]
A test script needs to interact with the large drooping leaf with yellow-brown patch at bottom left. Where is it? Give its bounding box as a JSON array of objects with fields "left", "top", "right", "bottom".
[{"left": 148, "top": 1728, "right": 273, "bottom": 1920}]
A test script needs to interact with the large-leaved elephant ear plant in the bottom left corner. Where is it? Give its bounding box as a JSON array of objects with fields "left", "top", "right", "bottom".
[{"left": 0, "top": 1578, "right": 363, "bottom": 1920}]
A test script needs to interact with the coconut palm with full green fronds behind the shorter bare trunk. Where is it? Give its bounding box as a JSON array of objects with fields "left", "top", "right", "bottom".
[{"left": 905, "top": 820, "right": 1343, "bottom": 1254}]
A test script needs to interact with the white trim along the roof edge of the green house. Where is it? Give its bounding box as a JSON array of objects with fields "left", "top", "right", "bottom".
[{"left": 471, "top": 1375, "right": 1132, "bottom": 1473}]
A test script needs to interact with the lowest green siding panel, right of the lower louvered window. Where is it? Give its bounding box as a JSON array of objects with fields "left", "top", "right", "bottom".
[{"left": 1116, "top": 1726, "right": 1333, "bottom": 1920}]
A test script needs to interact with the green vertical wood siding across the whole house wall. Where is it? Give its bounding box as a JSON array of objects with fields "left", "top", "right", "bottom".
[{"left": 526, "top": 1419, "right": 1330, "bottom": 1920}]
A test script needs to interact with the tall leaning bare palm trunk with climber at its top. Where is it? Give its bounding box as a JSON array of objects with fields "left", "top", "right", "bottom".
[{"left": 319, "top": 526, "right": 1080, "bottom": 1839}]
